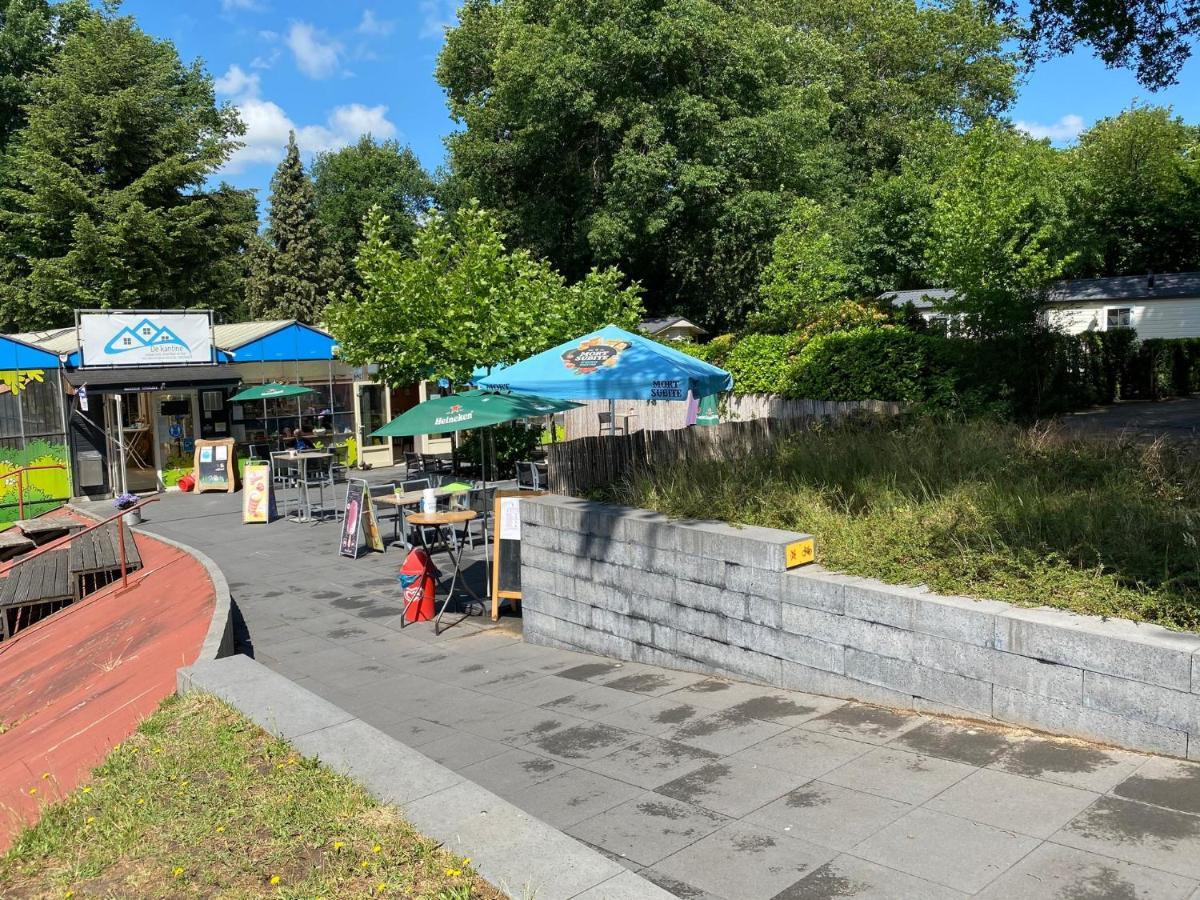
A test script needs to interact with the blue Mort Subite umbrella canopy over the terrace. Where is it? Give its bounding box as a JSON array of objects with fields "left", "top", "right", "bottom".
[{"left": 475, "top": 325, "right": 733, "bottom": 400}]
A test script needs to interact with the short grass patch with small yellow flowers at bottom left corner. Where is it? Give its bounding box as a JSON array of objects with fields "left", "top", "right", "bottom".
[{"left": 0, "top": 694, "right": 502, "bottom": 900}]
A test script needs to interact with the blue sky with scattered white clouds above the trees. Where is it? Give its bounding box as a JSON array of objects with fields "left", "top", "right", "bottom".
[{"left": 122, "top": 0, "right": 1200, "bottom": 206}]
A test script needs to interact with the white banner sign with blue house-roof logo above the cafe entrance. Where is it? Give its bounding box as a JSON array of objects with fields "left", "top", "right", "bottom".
[{"left": 79, "top": 312, "right": 212, "bottom": 366}]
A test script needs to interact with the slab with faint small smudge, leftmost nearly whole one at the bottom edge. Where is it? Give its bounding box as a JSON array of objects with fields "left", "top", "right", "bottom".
[{"left": 653, "top": 822, "right": 836, "bottom": 900}]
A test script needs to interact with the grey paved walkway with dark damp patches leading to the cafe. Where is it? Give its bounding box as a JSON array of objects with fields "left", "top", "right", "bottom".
[{"left": 133, "top": 487, "right": 1200, "bottom": 900}]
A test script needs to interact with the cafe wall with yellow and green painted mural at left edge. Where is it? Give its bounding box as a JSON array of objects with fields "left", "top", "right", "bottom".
[{"left": 0, "top": 368, "right": 71, "bottom": 526}]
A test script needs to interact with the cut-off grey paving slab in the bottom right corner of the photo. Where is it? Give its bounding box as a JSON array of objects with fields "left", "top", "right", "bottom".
[{"left": 977, "top": 844, "right": 1196, "bottom": 900}]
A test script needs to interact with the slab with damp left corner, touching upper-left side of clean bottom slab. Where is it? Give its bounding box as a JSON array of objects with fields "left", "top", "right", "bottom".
[{"left": 745, "top": 781, "right": 912, "bottom": 850}]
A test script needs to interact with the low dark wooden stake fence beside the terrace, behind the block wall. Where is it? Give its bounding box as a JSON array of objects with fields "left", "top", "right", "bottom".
[{"left": 546, "top": 400, "right": 900, "bottom": 496}]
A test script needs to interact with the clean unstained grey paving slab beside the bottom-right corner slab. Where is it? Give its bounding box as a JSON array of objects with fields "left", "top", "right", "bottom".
[{"left": 854, "top": 809, "right": 1038, "bottom": 894}]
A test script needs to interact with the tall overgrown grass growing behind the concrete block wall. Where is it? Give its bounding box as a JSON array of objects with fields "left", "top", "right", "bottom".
[{"left": 612, "top": 420, "right": 1200, "bottom": 629}]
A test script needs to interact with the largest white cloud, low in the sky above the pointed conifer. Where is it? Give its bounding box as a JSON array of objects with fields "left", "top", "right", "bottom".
[{"left": 224, "top": 96, "right": 396, "bottom": 174}]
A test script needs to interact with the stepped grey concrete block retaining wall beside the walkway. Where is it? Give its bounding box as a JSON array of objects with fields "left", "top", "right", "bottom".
[{"left": 521, "top": 496, "right": 1200, "bottom": 758}]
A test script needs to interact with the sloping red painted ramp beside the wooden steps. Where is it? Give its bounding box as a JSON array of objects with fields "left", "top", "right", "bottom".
[{"left": 0, "top": 525, "right": 216, "bottom": 850}]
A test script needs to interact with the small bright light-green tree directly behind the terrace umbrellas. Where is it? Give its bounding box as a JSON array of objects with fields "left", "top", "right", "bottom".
[{"left": 325, "top": 203, "right": 642, "bottom": 384}]
